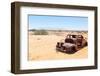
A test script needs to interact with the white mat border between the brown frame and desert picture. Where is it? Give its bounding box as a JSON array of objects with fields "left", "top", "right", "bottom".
[{"left": 20, "top": 7, "right": 94, "bottom": 70}]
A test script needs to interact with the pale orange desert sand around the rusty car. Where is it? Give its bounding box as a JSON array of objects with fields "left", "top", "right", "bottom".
[{"left": 28, "top": 31, "right": 88, "bottom": 60}]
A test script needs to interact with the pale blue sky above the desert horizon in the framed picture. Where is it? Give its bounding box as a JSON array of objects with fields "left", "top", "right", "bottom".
[{"left": 28, "top": 15, "right": 88, "bottom": 31}]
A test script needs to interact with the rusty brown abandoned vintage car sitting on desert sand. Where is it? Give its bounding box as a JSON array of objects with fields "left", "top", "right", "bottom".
[{"left": 56, "top": 34, "right": 87, "bottom": 54}]
